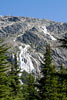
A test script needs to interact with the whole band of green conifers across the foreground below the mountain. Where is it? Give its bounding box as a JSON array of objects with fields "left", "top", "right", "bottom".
[{"left": 0, "top": 39, "right": 67, "bottom": 100}]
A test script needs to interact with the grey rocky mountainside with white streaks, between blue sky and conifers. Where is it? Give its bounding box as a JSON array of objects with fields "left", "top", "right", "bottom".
[{"left": 0, "top": 16, "right": 67, "bottom": 73}]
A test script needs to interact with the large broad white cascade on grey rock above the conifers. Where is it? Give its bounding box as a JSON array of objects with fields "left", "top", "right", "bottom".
[{"left": 18, "top": 45, "right": 34, "bottom": 75}]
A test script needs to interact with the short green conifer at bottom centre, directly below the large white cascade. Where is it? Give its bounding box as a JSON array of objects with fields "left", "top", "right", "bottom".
[{"left": 22, "top": 74, "right": 38, "bottom": 100}]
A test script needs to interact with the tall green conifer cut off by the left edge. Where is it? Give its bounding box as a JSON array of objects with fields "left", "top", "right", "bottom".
[{"left": 0, "top": 42, "right": 10, "bottom": 100}]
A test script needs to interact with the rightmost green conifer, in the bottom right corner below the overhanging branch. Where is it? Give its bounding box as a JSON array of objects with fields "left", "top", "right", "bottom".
[{"left": 56, "top": 66, "right": 67, "bottom": 100}]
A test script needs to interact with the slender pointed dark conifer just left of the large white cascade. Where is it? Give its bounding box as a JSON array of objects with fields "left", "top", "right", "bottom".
[{"left": 9, "top": 54, "right": 21, "bottom": 98}]
